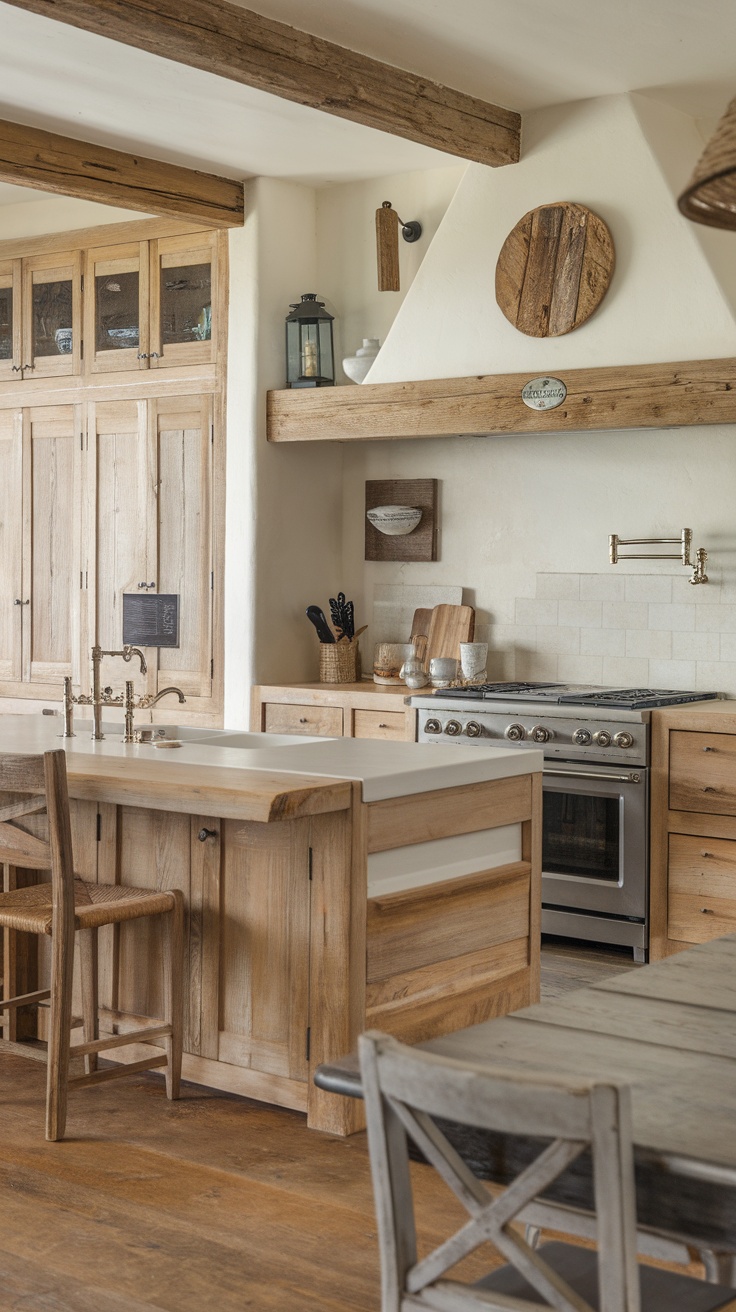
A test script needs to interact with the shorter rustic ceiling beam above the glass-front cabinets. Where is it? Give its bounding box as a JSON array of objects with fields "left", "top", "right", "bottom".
[{"left": 0, "top": 119, "right": 244, "bottom": 228}]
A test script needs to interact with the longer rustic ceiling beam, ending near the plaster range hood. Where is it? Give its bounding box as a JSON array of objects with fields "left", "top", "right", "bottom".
[{"left": 8, "top": 0, "right": 521, "bottom": 164}]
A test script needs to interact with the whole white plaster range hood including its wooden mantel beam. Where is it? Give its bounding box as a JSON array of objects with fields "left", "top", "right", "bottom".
[{"left": 268, "top": 94, "right": 736, "bottom": 442}]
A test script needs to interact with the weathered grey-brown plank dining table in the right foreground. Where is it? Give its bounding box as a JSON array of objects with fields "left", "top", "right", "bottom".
[{"left": 316, "top": 934, "right": 736, "bottom": 1254}]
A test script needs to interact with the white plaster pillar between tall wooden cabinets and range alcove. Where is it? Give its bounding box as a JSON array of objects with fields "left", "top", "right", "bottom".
[{"left": 224, "top": 178, "right": 344, "bottom": 727}]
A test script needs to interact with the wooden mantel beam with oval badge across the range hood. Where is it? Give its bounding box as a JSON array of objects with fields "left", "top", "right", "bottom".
[{"left": 266, "top": 358, "right": 736, "bottom": 442}]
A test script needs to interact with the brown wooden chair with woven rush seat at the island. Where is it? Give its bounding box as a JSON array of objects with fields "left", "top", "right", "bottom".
[{"left": 0, "top": 750, "right": 184, "bottom": 1140}]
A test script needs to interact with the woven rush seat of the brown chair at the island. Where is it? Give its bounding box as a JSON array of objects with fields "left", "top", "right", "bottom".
[{"left": 0, "top": 879, "right": 174, "bottom": 934}]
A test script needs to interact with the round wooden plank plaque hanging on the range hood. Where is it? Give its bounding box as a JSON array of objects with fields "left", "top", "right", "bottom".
[{"left": 496, "top": 201, "right": 615, "bottom": 337}]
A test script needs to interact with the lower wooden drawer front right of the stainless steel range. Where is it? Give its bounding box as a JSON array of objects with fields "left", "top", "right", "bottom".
[{"left": 668, "top": 833, "right": 736, "bottom": 943}]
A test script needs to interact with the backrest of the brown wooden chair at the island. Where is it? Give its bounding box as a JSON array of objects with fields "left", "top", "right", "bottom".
[{"left": 0, "top": 749, "right": 75, "bottom": 933}]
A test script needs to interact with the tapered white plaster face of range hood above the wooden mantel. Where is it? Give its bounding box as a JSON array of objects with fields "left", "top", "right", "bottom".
[{"left": 369, "top": 96, "right": 736, "bottom": 383}]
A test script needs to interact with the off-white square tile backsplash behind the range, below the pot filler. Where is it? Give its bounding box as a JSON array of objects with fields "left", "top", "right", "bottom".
[{"left": 488, "top": 571, "right": 736, "bottom": 697}]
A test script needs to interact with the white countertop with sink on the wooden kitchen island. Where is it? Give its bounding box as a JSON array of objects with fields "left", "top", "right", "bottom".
[{"left": 0, "top": 714, "right": 543, "bottom": 802}]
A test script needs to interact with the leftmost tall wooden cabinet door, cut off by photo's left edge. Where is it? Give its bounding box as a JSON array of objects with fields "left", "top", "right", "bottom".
[{"left": 0, "top": 409, "right": 22, "bottom": 682}]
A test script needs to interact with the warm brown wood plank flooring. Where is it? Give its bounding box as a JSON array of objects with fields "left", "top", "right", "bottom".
[{"left": 0, "top": 945, "right": 642, "bottom": 1312}]
